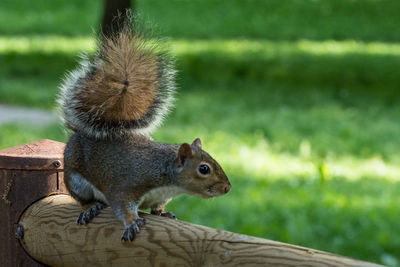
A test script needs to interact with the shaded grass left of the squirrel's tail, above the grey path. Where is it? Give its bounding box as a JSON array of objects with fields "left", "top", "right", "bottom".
[{"left": 0, "top": 53, "right": 77, "bottom": 109}]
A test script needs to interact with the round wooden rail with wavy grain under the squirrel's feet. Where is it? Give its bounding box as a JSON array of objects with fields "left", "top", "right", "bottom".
[{"left": 20, "top": 195, "right": 378, "bottom": 266}]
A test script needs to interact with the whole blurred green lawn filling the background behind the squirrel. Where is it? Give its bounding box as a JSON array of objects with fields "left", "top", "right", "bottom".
[{"left": 0, "top": 0, "right": 400, "bottom": 266}]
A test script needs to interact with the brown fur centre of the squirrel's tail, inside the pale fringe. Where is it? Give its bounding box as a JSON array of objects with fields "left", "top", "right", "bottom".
[{"left": 77, "top": 30, "right": 158, "bottom": 121}]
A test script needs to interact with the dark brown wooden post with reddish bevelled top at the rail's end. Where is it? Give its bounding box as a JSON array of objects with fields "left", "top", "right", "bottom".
[{"left": 0, "top": 140, "right": 66, "bottom": 266}]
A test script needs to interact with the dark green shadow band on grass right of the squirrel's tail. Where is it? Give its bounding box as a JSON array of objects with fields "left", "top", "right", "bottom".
[{"left": 178, "top": 52, "right": 400, "bottom": 96}]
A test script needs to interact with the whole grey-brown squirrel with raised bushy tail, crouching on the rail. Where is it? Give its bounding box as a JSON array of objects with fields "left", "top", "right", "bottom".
[{"left": 58, "top": 23, "right": 231, "bottom": 241}]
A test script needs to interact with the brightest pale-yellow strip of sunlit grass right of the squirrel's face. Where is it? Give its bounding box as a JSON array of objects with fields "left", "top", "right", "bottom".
[{"left": 225, "top": 139, "right": 400, "bottom": 181}]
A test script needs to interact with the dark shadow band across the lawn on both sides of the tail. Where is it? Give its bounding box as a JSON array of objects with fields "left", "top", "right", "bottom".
[{"left": 0, "top": 46, "right": 400, "bottom": 108}]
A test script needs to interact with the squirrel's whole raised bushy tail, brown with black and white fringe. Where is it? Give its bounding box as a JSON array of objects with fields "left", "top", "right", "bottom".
[{"left": 58, "top": 24, "right": 175, "bottom": 138}]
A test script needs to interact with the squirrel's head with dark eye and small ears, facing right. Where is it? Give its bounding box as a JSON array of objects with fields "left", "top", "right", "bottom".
[{"left": 175, "top": 138, "right": 231, "bottom": 198}]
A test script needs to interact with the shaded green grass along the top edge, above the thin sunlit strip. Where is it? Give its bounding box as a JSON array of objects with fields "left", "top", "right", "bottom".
[{"left": 0, "top": 0, "right": 400, "bottom": 42}]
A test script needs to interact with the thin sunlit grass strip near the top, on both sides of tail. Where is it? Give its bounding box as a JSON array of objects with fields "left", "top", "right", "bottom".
[{"left": 0, "top": 35, "right": 400, "bottom": 56}]
